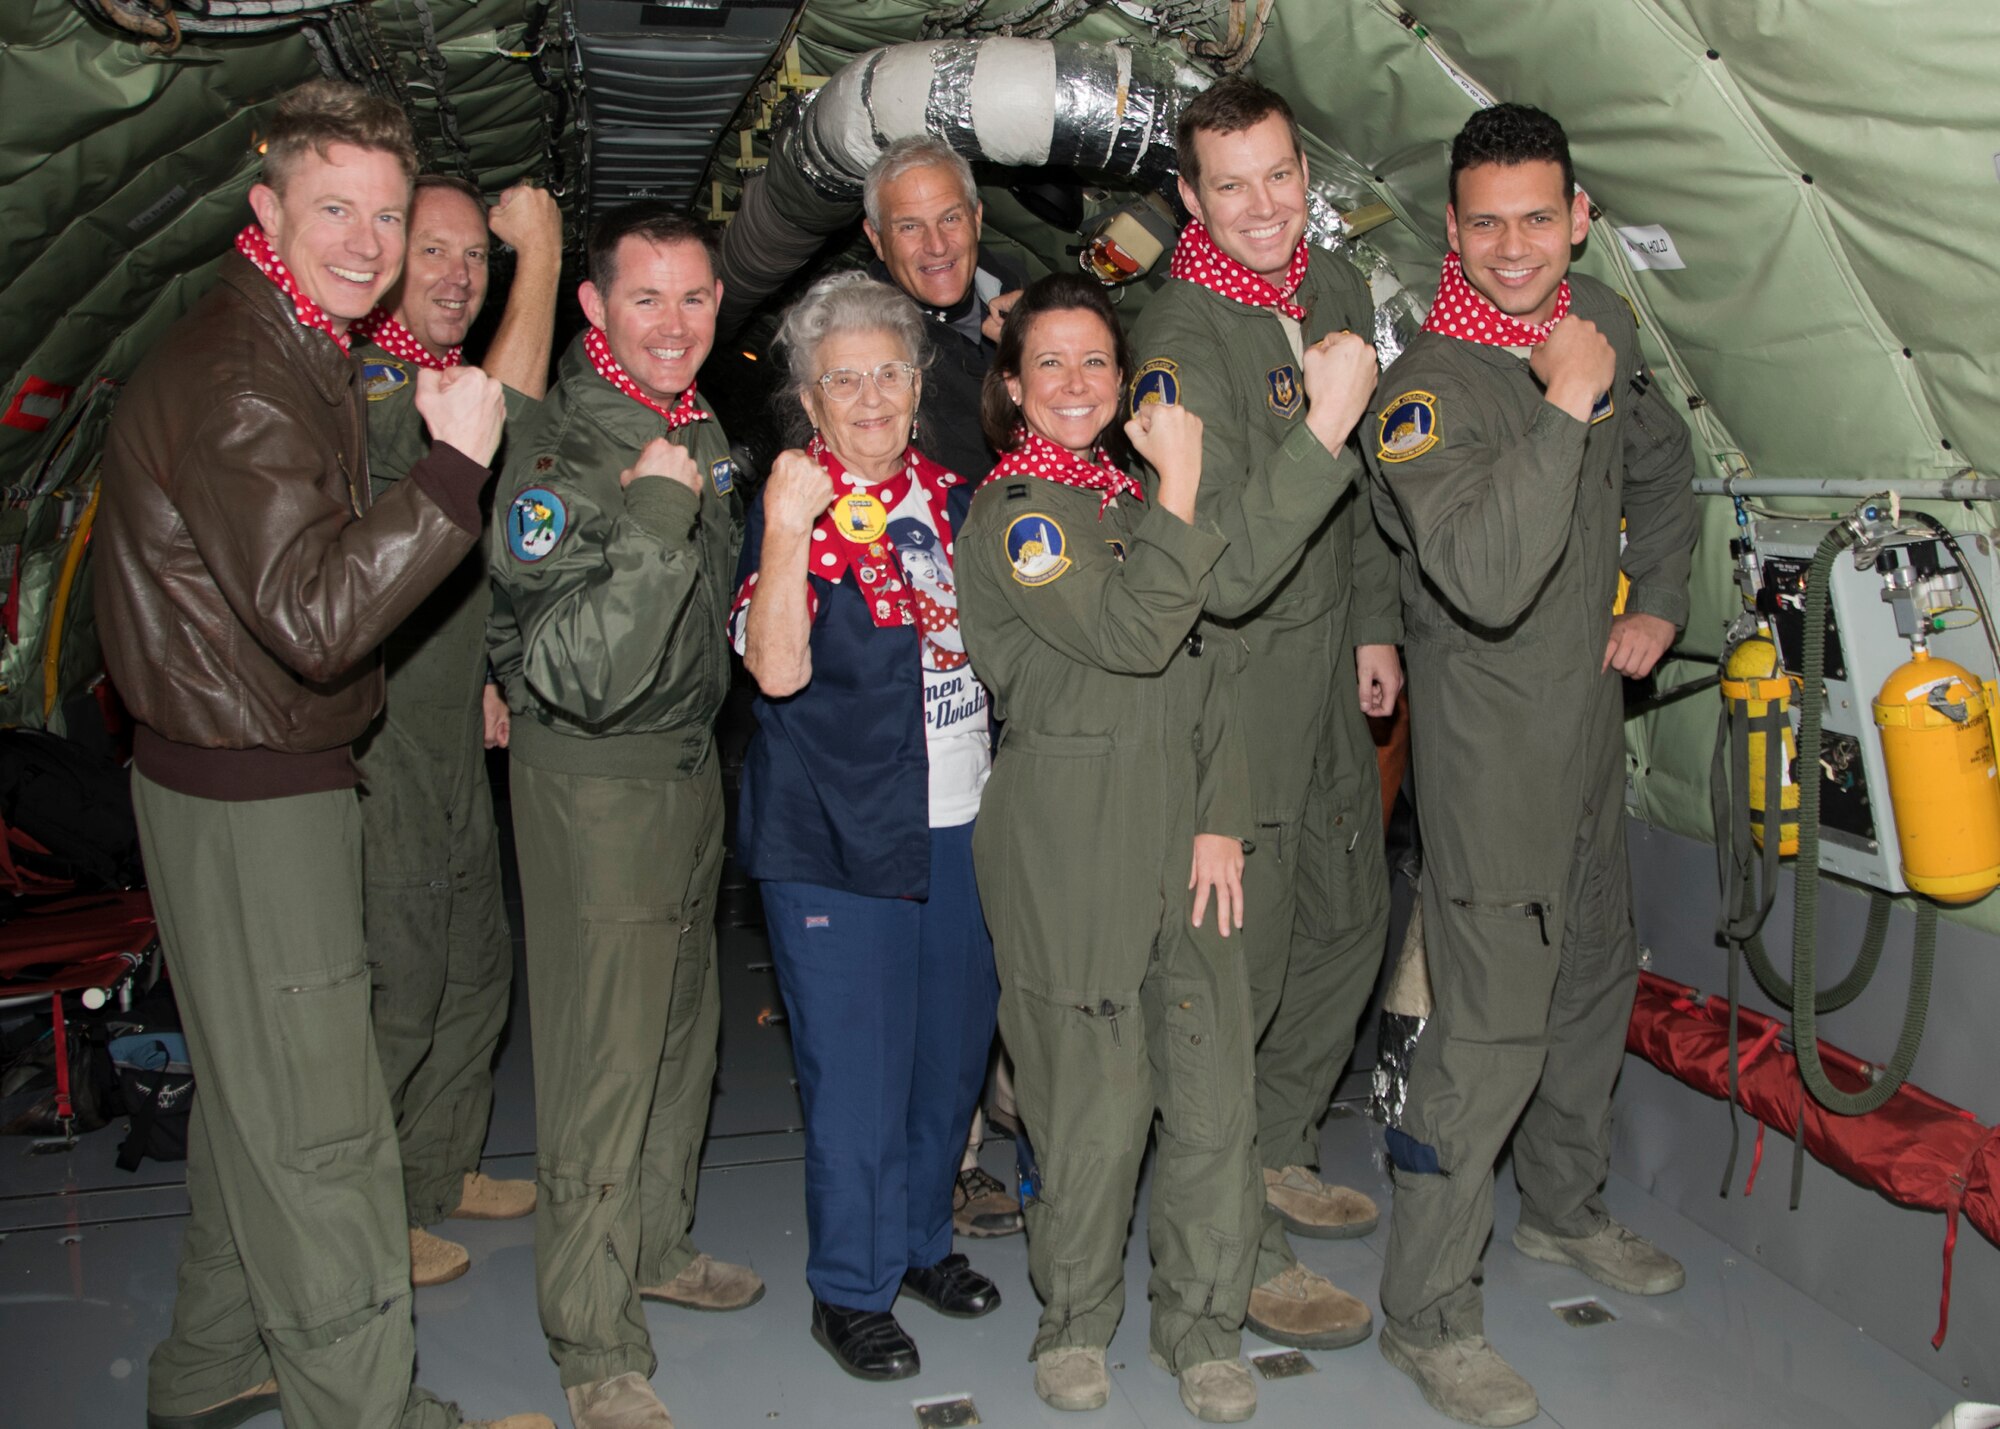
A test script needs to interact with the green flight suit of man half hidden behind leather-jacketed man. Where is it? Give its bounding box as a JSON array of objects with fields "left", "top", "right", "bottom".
[{"left": 354, "top": 342, "right": 534, "bottom": 1225}]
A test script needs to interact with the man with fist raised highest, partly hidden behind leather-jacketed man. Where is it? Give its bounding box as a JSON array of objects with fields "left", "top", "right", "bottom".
[{"left": 354, "top": 174, "right": 562, "bottom": 1285}]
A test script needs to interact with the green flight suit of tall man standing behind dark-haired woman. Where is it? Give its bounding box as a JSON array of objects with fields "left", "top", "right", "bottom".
[{"left": 1132, "top": 252, "right": 1402, "bottom": 1285}]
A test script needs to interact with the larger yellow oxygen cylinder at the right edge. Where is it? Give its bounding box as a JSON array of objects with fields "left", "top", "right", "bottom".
[{"left": 1874, "top": 648, "right": 2000, "bottom": 903}]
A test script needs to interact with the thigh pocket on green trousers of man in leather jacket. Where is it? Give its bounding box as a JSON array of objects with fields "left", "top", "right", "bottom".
[{"left": 268, "top": 963, "right": 376, "bottom": 1171}]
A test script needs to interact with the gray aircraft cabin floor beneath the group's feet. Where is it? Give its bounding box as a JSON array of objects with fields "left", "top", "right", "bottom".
[{"left": 0, "top": 764, "right": 1954, "bottom": 1429}]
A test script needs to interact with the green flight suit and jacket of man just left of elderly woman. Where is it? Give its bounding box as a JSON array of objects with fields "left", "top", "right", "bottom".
[{"left": 490, "top": 340, "right": 742, "bottom": 1387}]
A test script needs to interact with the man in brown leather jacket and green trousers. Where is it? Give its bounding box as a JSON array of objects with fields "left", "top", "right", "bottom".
[{"left": 96, "top": 82, "right": 550, "bottom": 1429}]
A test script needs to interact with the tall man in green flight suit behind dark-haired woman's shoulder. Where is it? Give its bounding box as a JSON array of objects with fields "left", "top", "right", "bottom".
[{"left": 1132, "top": 78, "right": 1402, "bottom": 1349}]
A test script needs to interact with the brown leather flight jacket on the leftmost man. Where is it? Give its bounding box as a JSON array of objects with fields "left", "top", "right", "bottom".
[{"left": 92, "top": 252, "right": 488, "bottom": 799}]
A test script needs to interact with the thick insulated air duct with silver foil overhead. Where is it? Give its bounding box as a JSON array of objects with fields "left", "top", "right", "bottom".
[{"left": 720, "top": 38, "right": 1208, "bottom": 334}]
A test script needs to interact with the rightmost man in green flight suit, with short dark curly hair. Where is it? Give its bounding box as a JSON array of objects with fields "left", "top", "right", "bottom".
[{"left": 1366, "top": 104, "right": 1696, "bottom": 1425}]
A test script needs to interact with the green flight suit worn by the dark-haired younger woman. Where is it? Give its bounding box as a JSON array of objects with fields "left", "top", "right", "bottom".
[{"left": 954, "top": 476, "right": 1262, "bottom": 1373}]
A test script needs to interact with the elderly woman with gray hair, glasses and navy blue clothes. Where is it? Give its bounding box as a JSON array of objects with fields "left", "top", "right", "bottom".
[{"left": 730, "top": 274, "right": 1000, "bottom": 1379}]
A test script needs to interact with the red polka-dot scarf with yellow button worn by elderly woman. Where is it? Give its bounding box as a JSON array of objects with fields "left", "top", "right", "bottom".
[{"left": 730, "top": 436, "right": 964, "bottom": 628}]
